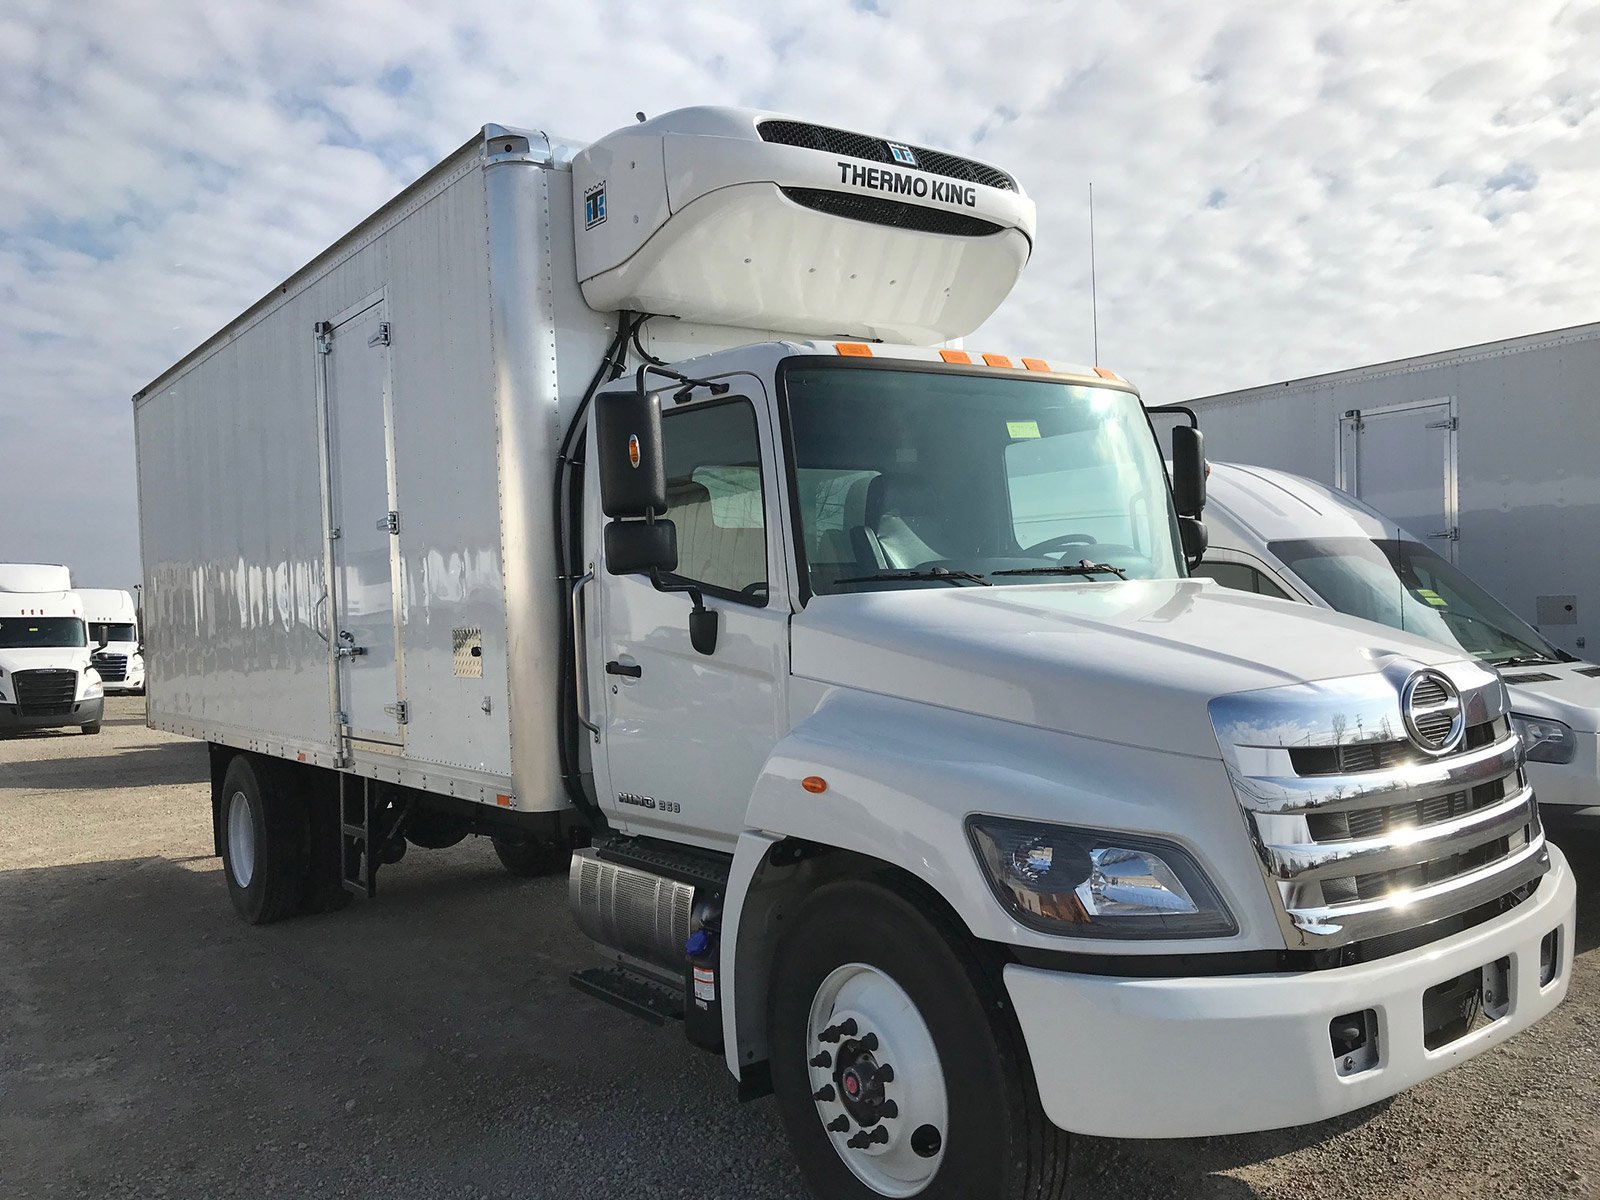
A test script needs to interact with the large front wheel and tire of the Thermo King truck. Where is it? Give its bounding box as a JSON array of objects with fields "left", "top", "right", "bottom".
[{"left": 768, "top": 880, "right": 1069, "bottom": 1200}]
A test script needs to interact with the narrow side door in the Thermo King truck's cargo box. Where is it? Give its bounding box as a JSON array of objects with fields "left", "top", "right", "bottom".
[{"left": 318, "top": 296, "right": 406, "bottom": 754}]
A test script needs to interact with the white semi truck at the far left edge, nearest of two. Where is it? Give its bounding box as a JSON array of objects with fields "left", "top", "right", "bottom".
[{"left": 0, "top": 563, "right": 106, "bottom": 734}]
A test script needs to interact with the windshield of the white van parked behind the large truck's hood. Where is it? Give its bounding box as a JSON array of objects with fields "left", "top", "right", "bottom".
[{"left": 1267, "top": 538, "right": 1560, "bottom": 662}]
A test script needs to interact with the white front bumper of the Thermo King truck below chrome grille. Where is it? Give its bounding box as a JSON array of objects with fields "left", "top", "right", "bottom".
[{"left": 1005, "top": 846, "right": 1576, "bottom": 1138}]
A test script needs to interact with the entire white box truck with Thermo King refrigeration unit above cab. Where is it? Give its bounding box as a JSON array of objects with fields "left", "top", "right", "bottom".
[{"left": 134, "top": 109, "right": 1574, "bottom": 1197}]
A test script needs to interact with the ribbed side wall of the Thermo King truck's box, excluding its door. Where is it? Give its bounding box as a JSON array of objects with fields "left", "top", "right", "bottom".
[{"left": 136, "top": 152, "right": 510, "bottom": 784}]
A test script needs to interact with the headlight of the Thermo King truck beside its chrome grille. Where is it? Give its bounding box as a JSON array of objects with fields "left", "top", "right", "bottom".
[{"left": 966, "top": 816, "right": 1238, "bottom": 938}]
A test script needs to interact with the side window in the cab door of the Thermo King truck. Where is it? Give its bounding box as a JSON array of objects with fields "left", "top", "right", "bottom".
[{"left": 661, "top": 398, "right": 768, "bottom": 606}]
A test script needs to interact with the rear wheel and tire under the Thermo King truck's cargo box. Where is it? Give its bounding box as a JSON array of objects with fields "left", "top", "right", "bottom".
[{"left": 221, "top": 754, "right": 310, "bottom": 925}]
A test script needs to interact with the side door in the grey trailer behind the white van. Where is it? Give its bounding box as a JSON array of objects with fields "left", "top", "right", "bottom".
[{"left": 1339, "top": 398, "right": 1461, "bottom": 562}]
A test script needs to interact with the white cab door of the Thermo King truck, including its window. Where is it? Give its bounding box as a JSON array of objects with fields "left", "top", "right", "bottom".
[{"left": 589, "top": 376, "right": 789, "bottom": 850}]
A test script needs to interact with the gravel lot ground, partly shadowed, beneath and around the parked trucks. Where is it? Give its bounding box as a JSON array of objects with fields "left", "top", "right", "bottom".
[{"left": 0, "top": 698, "right": 1600, "bottom": 1200}]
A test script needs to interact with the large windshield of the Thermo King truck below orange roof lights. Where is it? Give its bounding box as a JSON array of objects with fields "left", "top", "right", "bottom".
[{"left": 784, "top": 365, "right": 1182, "bottom": 595}]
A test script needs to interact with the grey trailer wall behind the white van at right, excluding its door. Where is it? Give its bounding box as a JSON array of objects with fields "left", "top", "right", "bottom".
[{"left": 1190, "top": 325, "right": 1600, "bottom": 658}]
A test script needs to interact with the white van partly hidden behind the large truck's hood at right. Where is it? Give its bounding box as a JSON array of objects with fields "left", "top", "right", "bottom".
[{"left": 1197, "top": 462, "right": 1600, "bottom": 824}]
